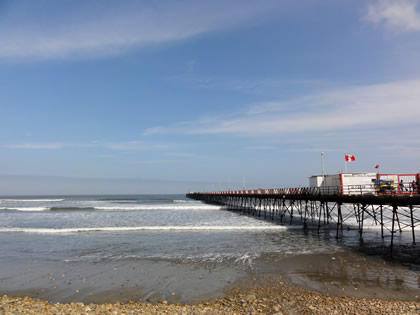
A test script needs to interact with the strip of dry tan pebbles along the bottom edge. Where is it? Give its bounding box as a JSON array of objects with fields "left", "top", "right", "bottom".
[{"left": 0, "top": 277, "right": 420, "bottom": 315}]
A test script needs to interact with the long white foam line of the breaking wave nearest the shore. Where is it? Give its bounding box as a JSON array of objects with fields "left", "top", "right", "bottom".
[{"left": 0, "top": 225, "right": 287, "bottom": 234}]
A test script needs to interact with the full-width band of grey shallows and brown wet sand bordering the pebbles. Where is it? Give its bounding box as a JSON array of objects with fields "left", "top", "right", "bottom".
[{"left": 0, "top": 251, "right": 420, "bottom": 304}]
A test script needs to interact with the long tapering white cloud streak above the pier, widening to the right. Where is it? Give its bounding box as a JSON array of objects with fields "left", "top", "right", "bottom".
[{"left": 147, "top": 80, "right": 420, "bottom": 136}]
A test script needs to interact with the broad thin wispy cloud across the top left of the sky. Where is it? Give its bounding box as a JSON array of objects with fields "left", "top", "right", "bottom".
[{"left": 0, "top": 0, "right": 274, "bottom": 58}]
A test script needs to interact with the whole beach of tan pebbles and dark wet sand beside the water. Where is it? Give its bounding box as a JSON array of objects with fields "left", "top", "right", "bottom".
[{"left": 0, "top": 253, "right": 420, "bottom": 314}]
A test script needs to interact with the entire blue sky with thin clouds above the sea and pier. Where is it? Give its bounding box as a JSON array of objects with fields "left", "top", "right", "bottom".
[{"left": 0, "top": 0, "right": 420, "bottom": 195}]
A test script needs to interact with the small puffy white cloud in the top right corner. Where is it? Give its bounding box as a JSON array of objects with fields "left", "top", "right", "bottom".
[{"left": 366, "top": 0, "right": 420, "bottom": 32}]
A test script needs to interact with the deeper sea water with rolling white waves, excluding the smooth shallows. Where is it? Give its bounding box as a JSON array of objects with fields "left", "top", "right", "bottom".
[{"left": 0, "top": 195, "right": 342, "bottom": 264}]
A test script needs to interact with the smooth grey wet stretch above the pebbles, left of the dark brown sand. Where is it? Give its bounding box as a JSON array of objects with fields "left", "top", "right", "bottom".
[{"left": 0, "top": 259, "right": 247, "bottom": 303}]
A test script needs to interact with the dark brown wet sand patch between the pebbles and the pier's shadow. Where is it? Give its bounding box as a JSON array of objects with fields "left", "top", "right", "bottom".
[{"left": 254, "top": 251, "right": 420, "bottom": 301}]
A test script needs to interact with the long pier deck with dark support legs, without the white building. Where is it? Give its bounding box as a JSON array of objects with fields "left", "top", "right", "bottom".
[{"left": 187, "top": 185, "right": 420, "bottom": 251}]
